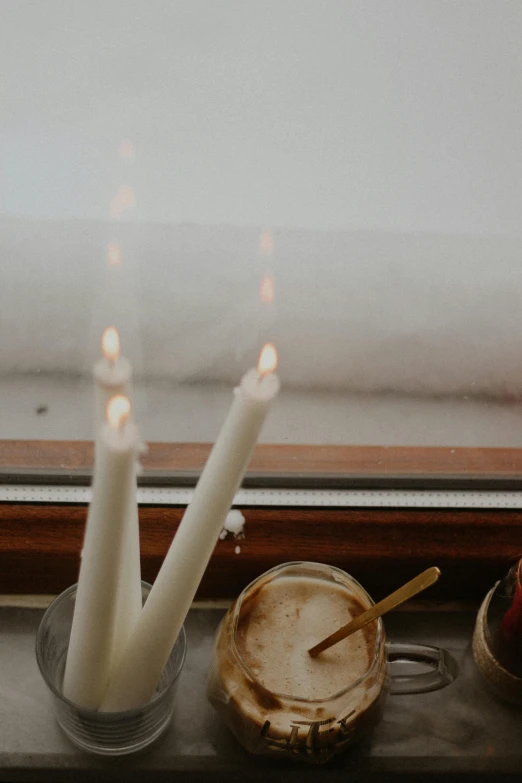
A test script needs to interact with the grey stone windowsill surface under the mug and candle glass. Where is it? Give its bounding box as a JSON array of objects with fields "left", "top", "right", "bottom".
[{"left": 0, "top": 608, "right": 522, "bottom": 783}]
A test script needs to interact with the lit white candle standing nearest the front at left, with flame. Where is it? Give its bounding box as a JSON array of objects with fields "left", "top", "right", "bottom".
[{"left": 63, "top": 396, "right": 140, "bottom": 709}]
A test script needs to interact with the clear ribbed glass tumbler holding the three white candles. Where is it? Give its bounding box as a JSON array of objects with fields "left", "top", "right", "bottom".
[{"left": 36, "top": 582, "right": 187, "bottom": 756}]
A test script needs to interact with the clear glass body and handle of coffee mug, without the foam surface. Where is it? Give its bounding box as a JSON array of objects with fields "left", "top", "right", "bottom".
[{"left": 207, "top": 562, "right": 457, "bottom": 763}]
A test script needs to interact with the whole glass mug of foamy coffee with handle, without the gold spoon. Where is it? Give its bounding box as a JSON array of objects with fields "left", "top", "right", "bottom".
[{"left": 207, "top": 562, "right": 456, "bottom": 763}]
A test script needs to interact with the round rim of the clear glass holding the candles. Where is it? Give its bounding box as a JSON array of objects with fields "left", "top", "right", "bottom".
[{"left": 35, "top": 579, "right": 187, "bottom": 720}]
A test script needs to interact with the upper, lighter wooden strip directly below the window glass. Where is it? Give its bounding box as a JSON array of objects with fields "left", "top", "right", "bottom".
[{"left": 0, "top": 440, "right": 522, "bottom": 486}]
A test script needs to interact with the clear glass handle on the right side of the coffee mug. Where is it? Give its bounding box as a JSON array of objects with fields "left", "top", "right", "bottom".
[{"left": 388, "top": 642, "right": 459, "bottom": 694}]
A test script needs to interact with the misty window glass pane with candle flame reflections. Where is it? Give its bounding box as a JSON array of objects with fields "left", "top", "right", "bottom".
[{"left": 0, "top": 0, "right": 522, "bottom": 454}]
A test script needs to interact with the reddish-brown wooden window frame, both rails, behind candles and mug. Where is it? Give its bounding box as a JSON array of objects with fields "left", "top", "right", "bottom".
[{"left": 0, "top": 441, "right": 522, "bottom": 601}]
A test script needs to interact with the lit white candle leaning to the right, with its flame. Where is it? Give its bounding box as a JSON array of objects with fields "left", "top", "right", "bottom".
[{"left": 97, "top": 345, "right": 279, "bottom": 711}]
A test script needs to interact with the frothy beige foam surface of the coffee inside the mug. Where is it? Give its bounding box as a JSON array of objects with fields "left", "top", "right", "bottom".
[{"left": 236, "top": 576, "right": 376, "bottom": 700}]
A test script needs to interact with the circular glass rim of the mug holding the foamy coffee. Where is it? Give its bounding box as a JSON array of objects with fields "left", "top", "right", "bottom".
[{"left": 231, "top": 560, "right": 384, "bottom": 704}]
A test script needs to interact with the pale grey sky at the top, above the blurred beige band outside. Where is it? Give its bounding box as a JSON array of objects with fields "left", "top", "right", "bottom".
[{"left": 0, "top": 0, "right": 522, "bottom": 233}]
